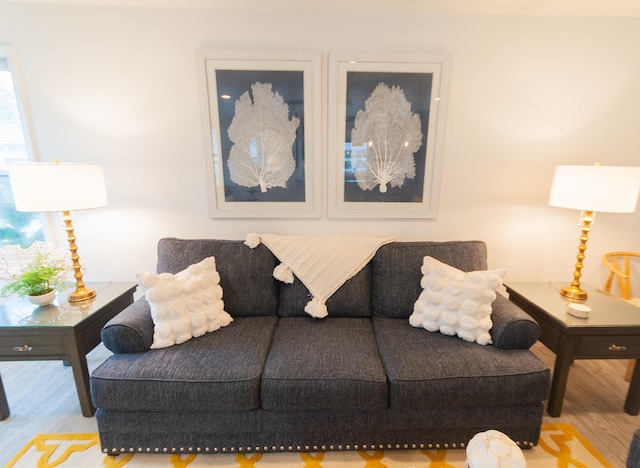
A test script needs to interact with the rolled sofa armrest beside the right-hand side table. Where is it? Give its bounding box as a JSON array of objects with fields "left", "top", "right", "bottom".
[{"left": 489, "top": 293, "right": 540, "bottom": 349}]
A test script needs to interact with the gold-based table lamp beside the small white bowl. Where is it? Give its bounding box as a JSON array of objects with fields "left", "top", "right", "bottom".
[{"left": 549, "top": 165, "right": 640, "bottom": 300}]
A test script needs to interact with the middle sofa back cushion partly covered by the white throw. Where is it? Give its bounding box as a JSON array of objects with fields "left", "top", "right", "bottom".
[{"left": 279, "top": 264, "right": 371, "bottom": 317}]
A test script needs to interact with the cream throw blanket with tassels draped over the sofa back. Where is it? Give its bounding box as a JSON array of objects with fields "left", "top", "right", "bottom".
[{"left": 245, "top": 234, "right": 395, "bottom": 318}]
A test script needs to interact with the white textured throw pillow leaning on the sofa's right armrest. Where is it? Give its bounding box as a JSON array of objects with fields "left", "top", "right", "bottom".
[{"left": 409, "top": 257, "right": 505, "bottom": 345}]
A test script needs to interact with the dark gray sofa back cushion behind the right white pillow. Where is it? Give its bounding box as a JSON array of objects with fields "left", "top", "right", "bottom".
[{"left": 371, "top": 241, "right": 487, "bottom": 318}]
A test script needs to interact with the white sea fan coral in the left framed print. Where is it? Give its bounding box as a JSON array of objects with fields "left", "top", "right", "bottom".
[{"left": 228, "top": 83, "right": 300, "bottom": 193}]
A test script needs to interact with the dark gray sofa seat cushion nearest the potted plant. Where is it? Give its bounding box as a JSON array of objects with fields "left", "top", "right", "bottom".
[{"left": 91, "top": 316, "right": 278, "bottom": 411}]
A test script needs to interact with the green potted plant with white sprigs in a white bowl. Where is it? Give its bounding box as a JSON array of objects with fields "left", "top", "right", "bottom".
[{"left": 0, "top": 241, "right": 72, "bottom": 305}]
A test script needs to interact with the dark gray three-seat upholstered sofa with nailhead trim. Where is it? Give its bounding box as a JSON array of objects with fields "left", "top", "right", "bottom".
[{"left": 91, "top": 238, "right": 550, "bottom": 453}]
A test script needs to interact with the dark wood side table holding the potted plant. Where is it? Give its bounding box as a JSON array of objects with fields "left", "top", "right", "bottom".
[{"left": 0, "top": 283, "right": 137, "bottom": 420}]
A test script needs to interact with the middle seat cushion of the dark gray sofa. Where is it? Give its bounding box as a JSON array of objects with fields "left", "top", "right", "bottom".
[{"left": 261, "top": 316, "right": 388, "bottom": 411}]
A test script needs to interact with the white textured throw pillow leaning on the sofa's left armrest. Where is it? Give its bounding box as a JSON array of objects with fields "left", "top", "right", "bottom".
[{"left": 136, "top": 257, "right": 233, "bottom": 348}]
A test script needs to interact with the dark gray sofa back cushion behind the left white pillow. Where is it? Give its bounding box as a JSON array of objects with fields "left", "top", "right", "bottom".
[{"left": 157, "top": 238, "right": 279, "bottom": 317}]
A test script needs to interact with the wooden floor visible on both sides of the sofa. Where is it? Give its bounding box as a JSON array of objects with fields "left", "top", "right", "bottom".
[{"left": 0, "top": 343, "right": 640, "bottom": 468}]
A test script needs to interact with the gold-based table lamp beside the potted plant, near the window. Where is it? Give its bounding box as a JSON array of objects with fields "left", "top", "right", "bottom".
[{"left": 8, "top": 162, "right": 107, "bottom": 302}]
